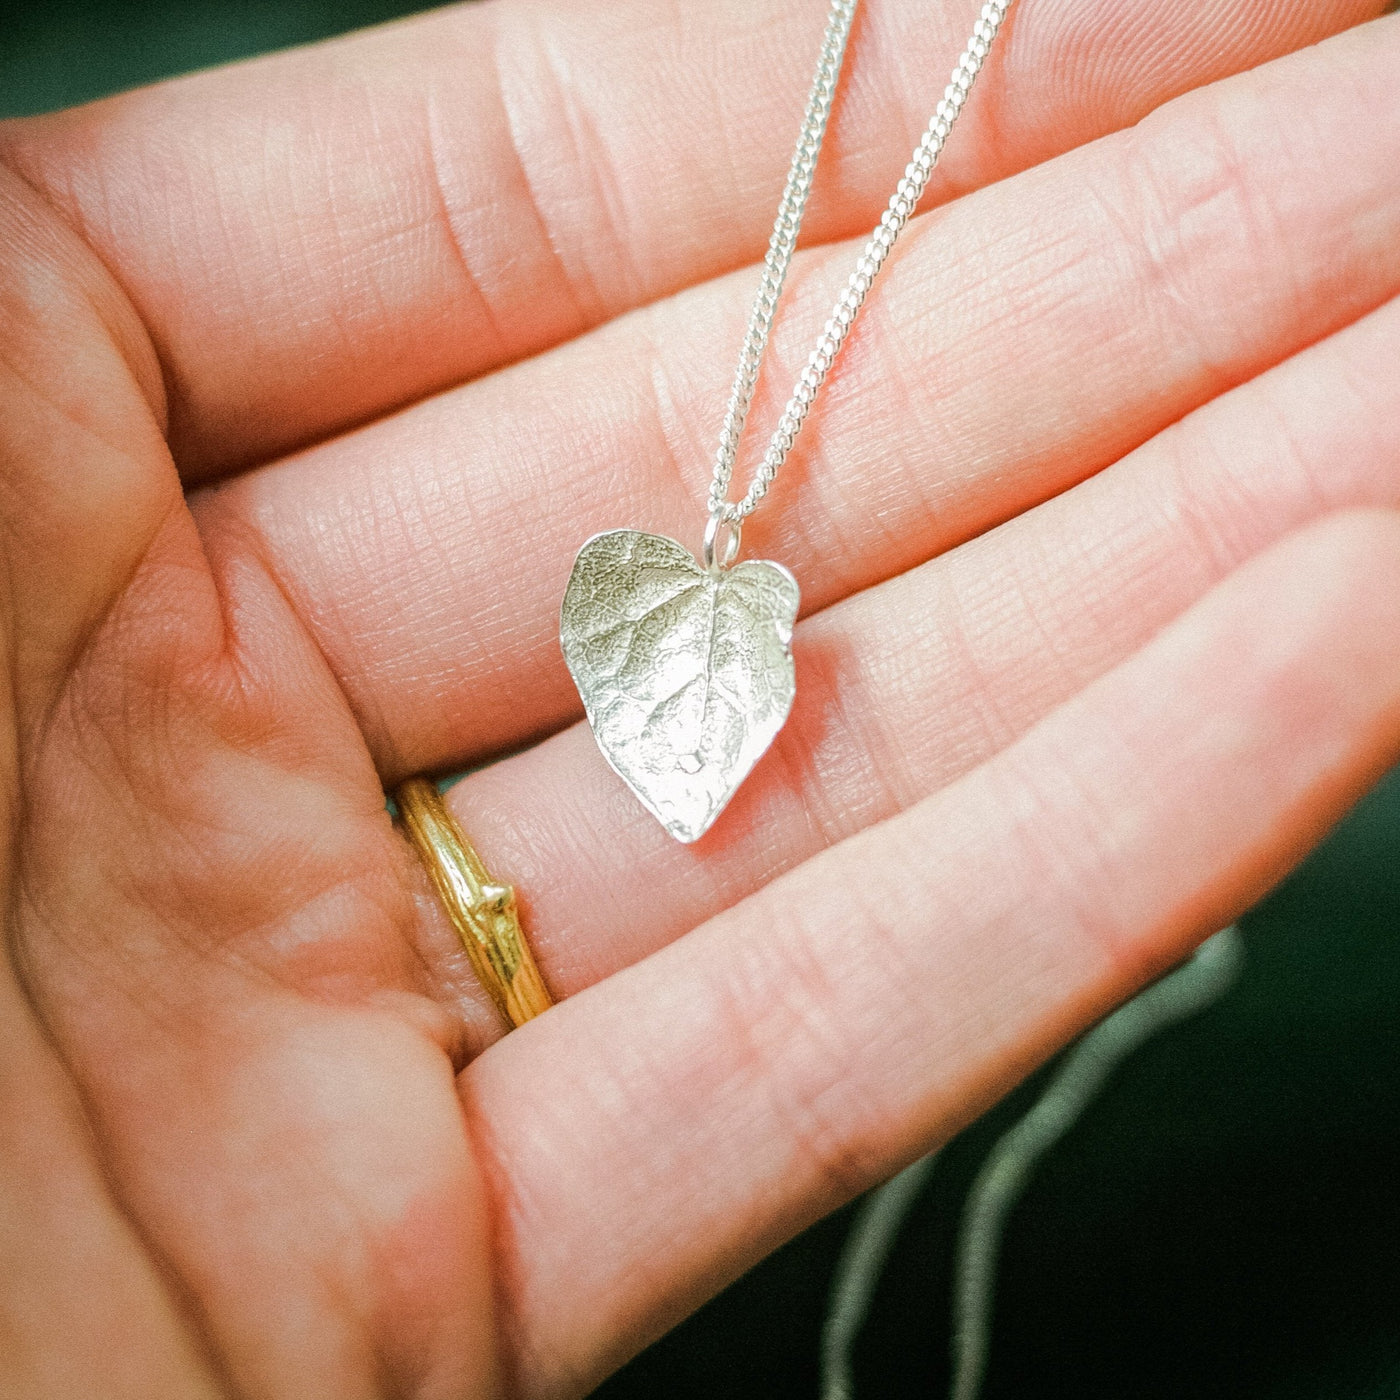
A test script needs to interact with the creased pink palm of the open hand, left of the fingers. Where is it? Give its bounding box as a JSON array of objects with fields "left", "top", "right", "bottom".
[{"left": 0, "top": 158, "right": 496, "bottom": 1400}]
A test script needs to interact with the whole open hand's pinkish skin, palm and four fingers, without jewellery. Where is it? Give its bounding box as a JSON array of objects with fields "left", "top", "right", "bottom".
[{"left": 0, "top": 0, "right": 1400, "bottom": 1400}]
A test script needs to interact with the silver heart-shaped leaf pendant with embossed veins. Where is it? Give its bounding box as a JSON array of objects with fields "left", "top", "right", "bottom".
[{"left": 559, "top": 529, "right": 798, "bottom": 841}]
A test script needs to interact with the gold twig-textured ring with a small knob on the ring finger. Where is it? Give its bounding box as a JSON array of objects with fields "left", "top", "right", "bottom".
[{"left": 393, "top": 778, "right": 553, "bottom": 1026}]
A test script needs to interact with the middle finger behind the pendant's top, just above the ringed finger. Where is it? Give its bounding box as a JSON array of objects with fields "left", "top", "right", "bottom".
[{"left": 200, "top": 20, "right": 1400, "bottom": 780}]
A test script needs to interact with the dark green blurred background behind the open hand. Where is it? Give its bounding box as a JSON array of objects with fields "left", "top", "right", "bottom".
[{"left": 0, "top": 0, "right": 1400, "bottom": 1400}]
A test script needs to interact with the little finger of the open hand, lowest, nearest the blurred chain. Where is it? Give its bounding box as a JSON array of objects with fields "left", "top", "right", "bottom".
[{"left": 461, "top": 514, "right": 1400, "bottom": 1394}]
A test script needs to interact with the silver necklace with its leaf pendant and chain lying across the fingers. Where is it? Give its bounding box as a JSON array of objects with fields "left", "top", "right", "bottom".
[{"left": 560, "top": 0, "right": 1012, "bottom": 841}]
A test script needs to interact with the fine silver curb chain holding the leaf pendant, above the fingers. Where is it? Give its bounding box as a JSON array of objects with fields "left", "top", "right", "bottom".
[{"left": 704, "top": 0, "right": 1012, "bottom": 551}]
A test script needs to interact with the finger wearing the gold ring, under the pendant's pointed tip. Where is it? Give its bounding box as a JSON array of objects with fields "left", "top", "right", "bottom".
[{"left": 423, "top": 287, "right": 1400, "bottom": 998}]
